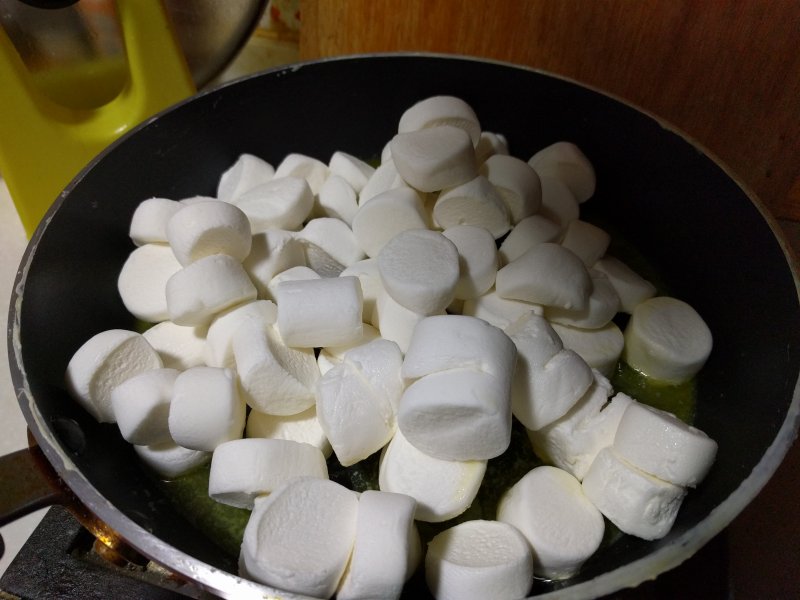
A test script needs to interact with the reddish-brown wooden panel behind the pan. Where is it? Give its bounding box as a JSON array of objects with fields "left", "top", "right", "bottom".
[{"left": 300, "top": 0, "right": 800, "bottom": 220}]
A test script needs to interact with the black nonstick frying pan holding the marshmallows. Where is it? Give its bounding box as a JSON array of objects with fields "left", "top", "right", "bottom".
[{"left": 9, "top": 54, "right": 800, "bottom": 598}]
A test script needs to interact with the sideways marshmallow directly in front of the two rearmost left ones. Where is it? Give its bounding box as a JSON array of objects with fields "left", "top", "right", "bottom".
[{"left": 235, "top": 176, "right": 314, "bottom": 233}]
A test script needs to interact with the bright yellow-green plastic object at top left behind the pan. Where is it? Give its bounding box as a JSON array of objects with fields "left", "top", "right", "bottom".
[{"left": 0, "top": 0, "right": 196, "bottom": 236}]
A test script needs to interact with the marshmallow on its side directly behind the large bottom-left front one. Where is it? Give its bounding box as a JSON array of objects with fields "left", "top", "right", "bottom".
[{"left": 208, "top": 438, "right": 328, "bottom": 510}]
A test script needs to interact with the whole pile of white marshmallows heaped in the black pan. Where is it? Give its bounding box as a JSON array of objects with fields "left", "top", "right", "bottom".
[{"left": 67, "top": 96, "right": 716, "bottom": 600}]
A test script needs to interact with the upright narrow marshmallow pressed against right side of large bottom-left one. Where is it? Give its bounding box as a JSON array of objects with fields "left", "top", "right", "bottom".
[{"left": 336, "top": 490, "right": 421, "bottom": 600}]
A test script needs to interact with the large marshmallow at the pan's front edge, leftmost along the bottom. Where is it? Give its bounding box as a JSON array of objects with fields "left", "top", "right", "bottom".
[{"left": 239, "top": 477, "right": 359, "bottom": 598}]
